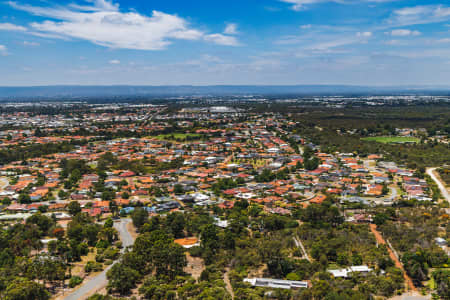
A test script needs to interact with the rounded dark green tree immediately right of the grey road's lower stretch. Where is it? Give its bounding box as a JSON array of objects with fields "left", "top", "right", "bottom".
[{"left": 106, "top": 263, "right": 140, "bottom": 295}]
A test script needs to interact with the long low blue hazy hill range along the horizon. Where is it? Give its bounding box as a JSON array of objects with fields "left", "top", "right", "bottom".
[{"left": 0, "top": 85, "right": 450, "bottom": 99}]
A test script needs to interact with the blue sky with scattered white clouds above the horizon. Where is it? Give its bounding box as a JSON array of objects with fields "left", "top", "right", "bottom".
[{"left": 0, "top": 0, "right": 450, "bottom": 86}]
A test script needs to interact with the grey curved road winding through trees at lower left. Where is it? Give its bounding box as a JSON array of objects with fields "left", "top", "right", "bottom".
[{"left": 64, "top": 219, "right": 134, "bottom": 300}]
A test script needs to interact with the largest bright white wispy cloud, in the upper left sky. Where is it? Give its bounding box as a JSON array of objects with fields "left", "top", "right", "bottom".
[{"left": 8, "top": 0, "right": 238, "bottom": 50}]
